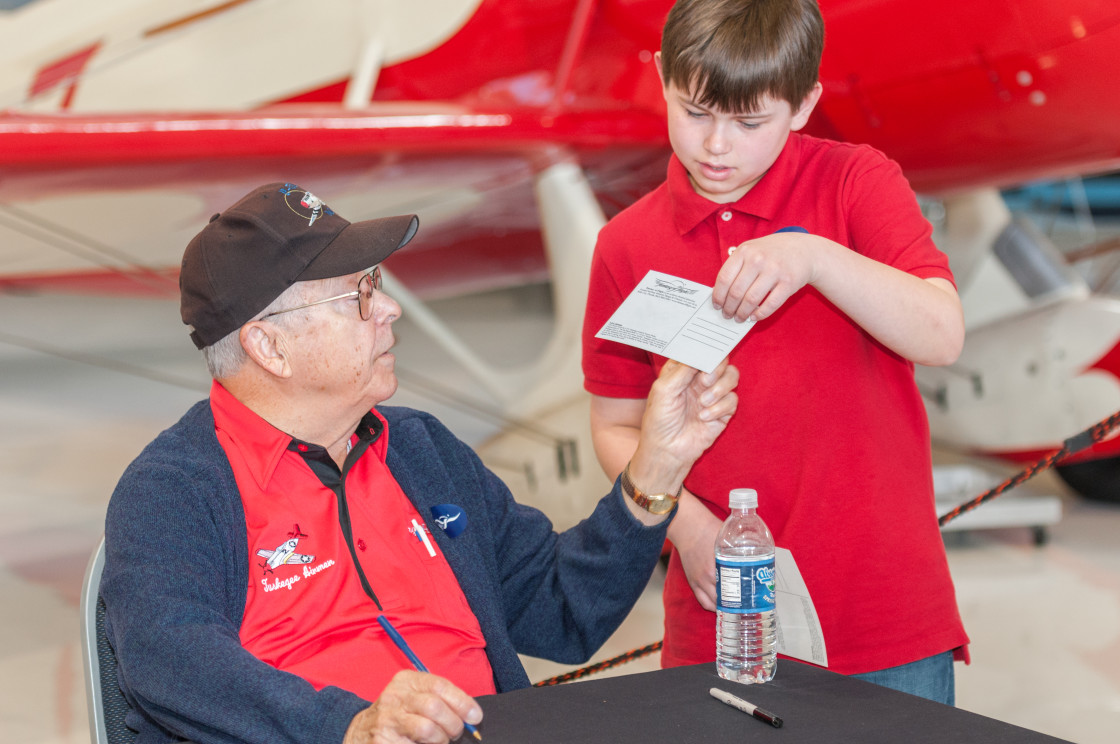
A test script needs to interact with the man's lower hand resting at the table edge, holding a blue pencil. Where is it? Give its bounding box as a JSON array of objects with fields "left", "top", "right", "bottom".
[{"left": 343, "top": 670, "right": 483, "bottom": 744}]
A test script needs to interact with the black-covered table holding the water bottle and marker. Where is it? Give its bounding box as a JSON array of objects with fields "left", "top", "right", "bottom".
[{"left": 465, "top": 659, "right": 1064, "bottom": 744}]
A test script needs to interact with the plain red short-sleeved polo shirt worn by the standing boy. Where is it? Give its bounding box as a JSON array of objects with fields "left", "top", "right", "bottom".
[{"left": 584, "top": 134, "right": 968, "bottom": 673}]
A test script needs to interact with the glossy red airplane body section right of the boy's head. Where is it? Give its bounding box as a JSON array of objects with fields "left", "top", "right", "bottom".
[{"left": 813, "top": 0, "right": 1120, "bottom": 194}]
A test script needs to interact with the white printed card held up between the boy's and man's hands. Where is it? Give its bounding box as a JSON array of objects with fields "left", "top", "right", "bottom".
[{"left": 595, "top": 271, "right": 755, "bottom": 372}]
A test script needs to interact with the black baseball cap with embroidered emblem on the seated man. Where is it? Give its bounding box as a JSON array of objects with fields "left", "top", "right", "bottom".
[{"left": 179, "top": 183, "right": 420, "bottom": 348}]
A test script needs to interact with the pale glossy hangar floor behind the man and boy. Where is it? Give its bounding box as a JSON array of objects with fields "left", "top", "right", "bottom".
[{"left": 0, "top": 279, "right": 1120, "bottom": 744}]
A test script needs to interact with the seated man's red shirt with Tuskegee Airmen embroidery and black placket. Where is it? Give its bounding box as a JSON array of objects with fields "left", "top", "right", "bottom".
[{"left": 211, "top": 382, "right": 496, "bottom": 700}]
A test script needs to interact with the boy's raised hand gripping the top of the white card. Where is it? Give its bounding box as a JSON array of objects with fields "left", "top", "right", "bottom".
[{"left": 711, "top": 232, "right": 818, "bottom": 323}]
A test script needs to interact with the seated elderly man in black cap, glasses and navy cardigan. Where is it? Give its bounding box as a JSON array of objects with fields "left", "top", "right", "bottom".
[{"left": 101, "top": 184, "right": 737, "bottom": 744}]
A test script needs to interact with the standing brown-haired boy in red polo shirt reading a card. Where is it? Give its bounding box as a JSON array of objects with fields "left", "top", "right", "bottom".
[{"left": 584, "top": 0, "right": 968, "bottom": 704}]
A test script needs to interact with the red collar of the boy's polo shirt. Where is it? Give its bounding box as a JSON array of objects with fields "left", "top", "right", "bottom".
[{"left": 665, "top": 132, "right": 801, "bottom": 235}]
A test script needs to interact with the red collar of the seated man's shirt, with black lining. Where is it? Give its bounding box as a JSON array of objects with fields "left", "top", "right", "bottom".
[{"left": 209, "top": 380, "right": 389, "bottom": 491}]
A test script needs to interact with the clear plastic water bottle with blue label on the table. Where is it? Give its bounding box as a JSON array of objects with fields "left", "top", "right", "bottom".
[{"left": 716, "top": 489, "right": 777, "bottom": 683}]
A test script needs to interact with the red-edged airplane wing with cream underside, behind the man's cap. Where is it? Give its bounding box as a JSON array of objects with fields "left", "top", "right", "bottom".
[{"left": 0, "top": 104, "right": 668, "bottom": 297}]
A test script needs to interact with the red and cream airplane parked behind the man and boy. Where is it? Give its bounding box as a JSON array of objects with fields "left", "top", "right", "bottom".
[{"left": 0, "top": 0, "right": 1120, "bottom": 499}]
